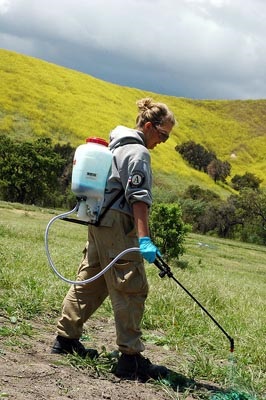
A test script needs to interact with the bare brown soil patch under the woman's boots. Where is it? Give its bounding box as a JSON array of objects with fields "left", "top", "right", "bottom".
[{"left": 0, "top": 317, "right": 220, "bottom": 400}]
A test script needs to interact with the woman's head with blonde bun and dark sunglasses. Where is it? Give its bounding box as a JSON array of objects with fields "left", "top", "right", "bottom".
[{"left": 136, "top": 97, "right": 176, "bottom": 149}]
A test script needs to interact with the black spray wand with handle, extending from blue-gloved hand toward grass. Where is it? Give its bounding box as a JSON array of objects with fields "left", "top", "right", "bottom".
[{"left": 154, "top": 255, "right": 234, "bottom": 353}]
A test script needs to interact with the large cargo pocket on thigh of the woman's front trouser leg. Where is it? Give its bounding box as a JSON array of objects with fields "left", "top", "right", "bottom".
[{"left": 111, "top": 259, "right": 148, "bottom": 294}]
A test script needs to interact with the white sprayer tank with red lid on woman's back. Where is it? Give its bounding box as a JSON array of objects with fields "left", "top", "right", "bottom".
[{"left": 71, "top": 137, "right": 113, "bottom": 222}]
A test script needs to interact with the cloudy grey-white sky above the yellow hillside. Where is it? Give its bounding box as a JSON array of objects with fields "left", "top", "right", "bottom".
[{"left": 0, "top": 0, "right": 266, "bottom": 100}]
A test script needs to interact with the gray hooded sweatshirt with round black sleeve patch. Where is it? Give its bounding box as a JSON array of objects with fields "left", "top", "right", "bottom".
[{"left": 103, "top": 126, "right": 152, "bottom": 215}]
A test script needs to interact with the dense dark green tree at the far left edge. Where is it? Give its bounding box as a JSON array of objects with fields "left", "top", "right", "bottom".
[{"left": 0, "top": 138, "right": 64, "bottom": 205}]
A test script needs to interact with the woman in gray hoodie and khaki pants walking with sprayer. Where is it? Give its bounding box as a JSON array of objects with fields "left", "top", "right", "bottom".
[{"left": 52, "top": 98, "right": 175, "bottom": 381}]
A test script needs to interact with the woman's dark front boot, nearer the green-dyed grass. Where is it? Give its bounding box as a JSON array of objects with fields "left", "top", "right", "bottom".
[{"left": 115, "top": 354, "right": 169, "bottom": 382}]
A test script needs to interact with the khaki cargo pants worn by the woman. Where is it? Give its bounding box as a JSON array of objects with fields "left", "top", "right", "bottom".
[{"left": 57, "top": 210, "right": 148, "bottom": 354}]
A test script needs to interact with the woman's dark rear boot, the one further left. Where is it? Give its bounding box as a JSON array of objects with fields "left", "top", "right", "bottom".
[{"left": 51, "top": 335, "right": 99, "bottom": 359}]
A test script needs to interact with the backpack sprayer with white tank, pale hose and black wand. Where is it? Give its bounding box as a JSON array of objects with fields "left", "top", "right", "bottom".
[{"left": 45, "top": 137, "right": 234, "bottom": 352}]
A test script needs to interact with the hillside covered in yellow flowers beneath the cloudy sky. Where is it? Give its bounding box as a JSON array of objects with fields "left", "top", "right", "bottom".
[{"left": 0, "top": 50, "right": 266, "bottom": 197}]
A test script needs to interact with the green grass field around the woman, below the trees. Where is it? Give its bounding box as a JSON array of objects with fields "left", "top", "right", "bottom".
[{"left": 0, "top": 202, "right": 266, "bottom": 399}]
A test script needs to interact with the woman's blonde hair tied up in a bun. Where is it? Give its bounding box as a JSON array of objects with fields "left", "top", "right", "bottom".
[{"left": 136, "top": 97, "right": 176, "bottom": 128}]
